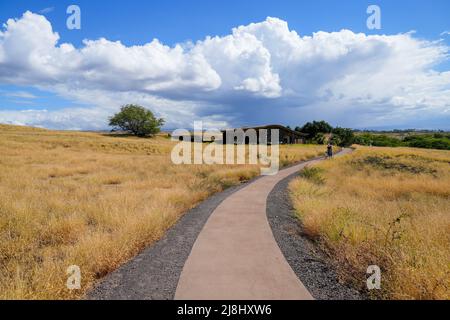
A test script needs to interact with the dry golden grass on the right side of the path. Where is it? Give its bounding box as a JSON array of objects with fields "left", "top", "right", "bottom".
[{"left": 290, "top": 147, "right": 450, "bottom": 299}]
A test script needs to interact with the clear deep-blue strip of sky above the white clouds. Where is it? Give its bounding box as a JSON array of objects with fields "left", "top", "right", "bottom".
[{"left": 0, "top": 0, "right": 450, "bottom": 46}]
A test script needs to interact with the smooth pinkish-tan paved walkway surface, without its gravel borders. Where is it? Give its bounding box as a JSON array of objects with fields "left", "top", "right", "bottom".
[{"left": 175, "top": 149, "right": 349, "bottom": 300}]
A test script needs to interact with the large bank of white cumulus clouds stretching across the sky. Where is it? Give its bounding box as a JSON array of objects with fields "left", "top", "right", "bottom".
[{"left": 0, "top": 12, "right": 450, "bottom": 129}]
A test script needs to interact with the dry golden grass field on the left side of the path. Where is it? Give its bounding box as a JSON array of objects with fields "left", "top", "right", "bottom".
[{"left": 0, "top": 125, "right": 324, "bottom": 299}]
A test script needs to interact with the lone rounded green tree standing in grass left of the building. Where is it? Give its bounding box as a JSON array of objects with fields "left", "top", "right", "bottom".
[{"left": 109, "top": 104, "right": 164, "bottom": 137}]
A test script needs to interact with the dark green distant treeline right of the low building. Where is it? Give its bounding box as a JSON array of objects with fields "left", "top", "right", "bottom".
[{"left": 294, "top": 121, "right": 450, "bottom": 150}]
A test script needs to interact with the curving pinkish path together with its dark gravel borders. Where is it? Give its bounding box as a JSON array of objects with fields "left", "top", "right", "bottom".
[{"left": 86, "top": 149, "right": 355, "bottom": 300}]
